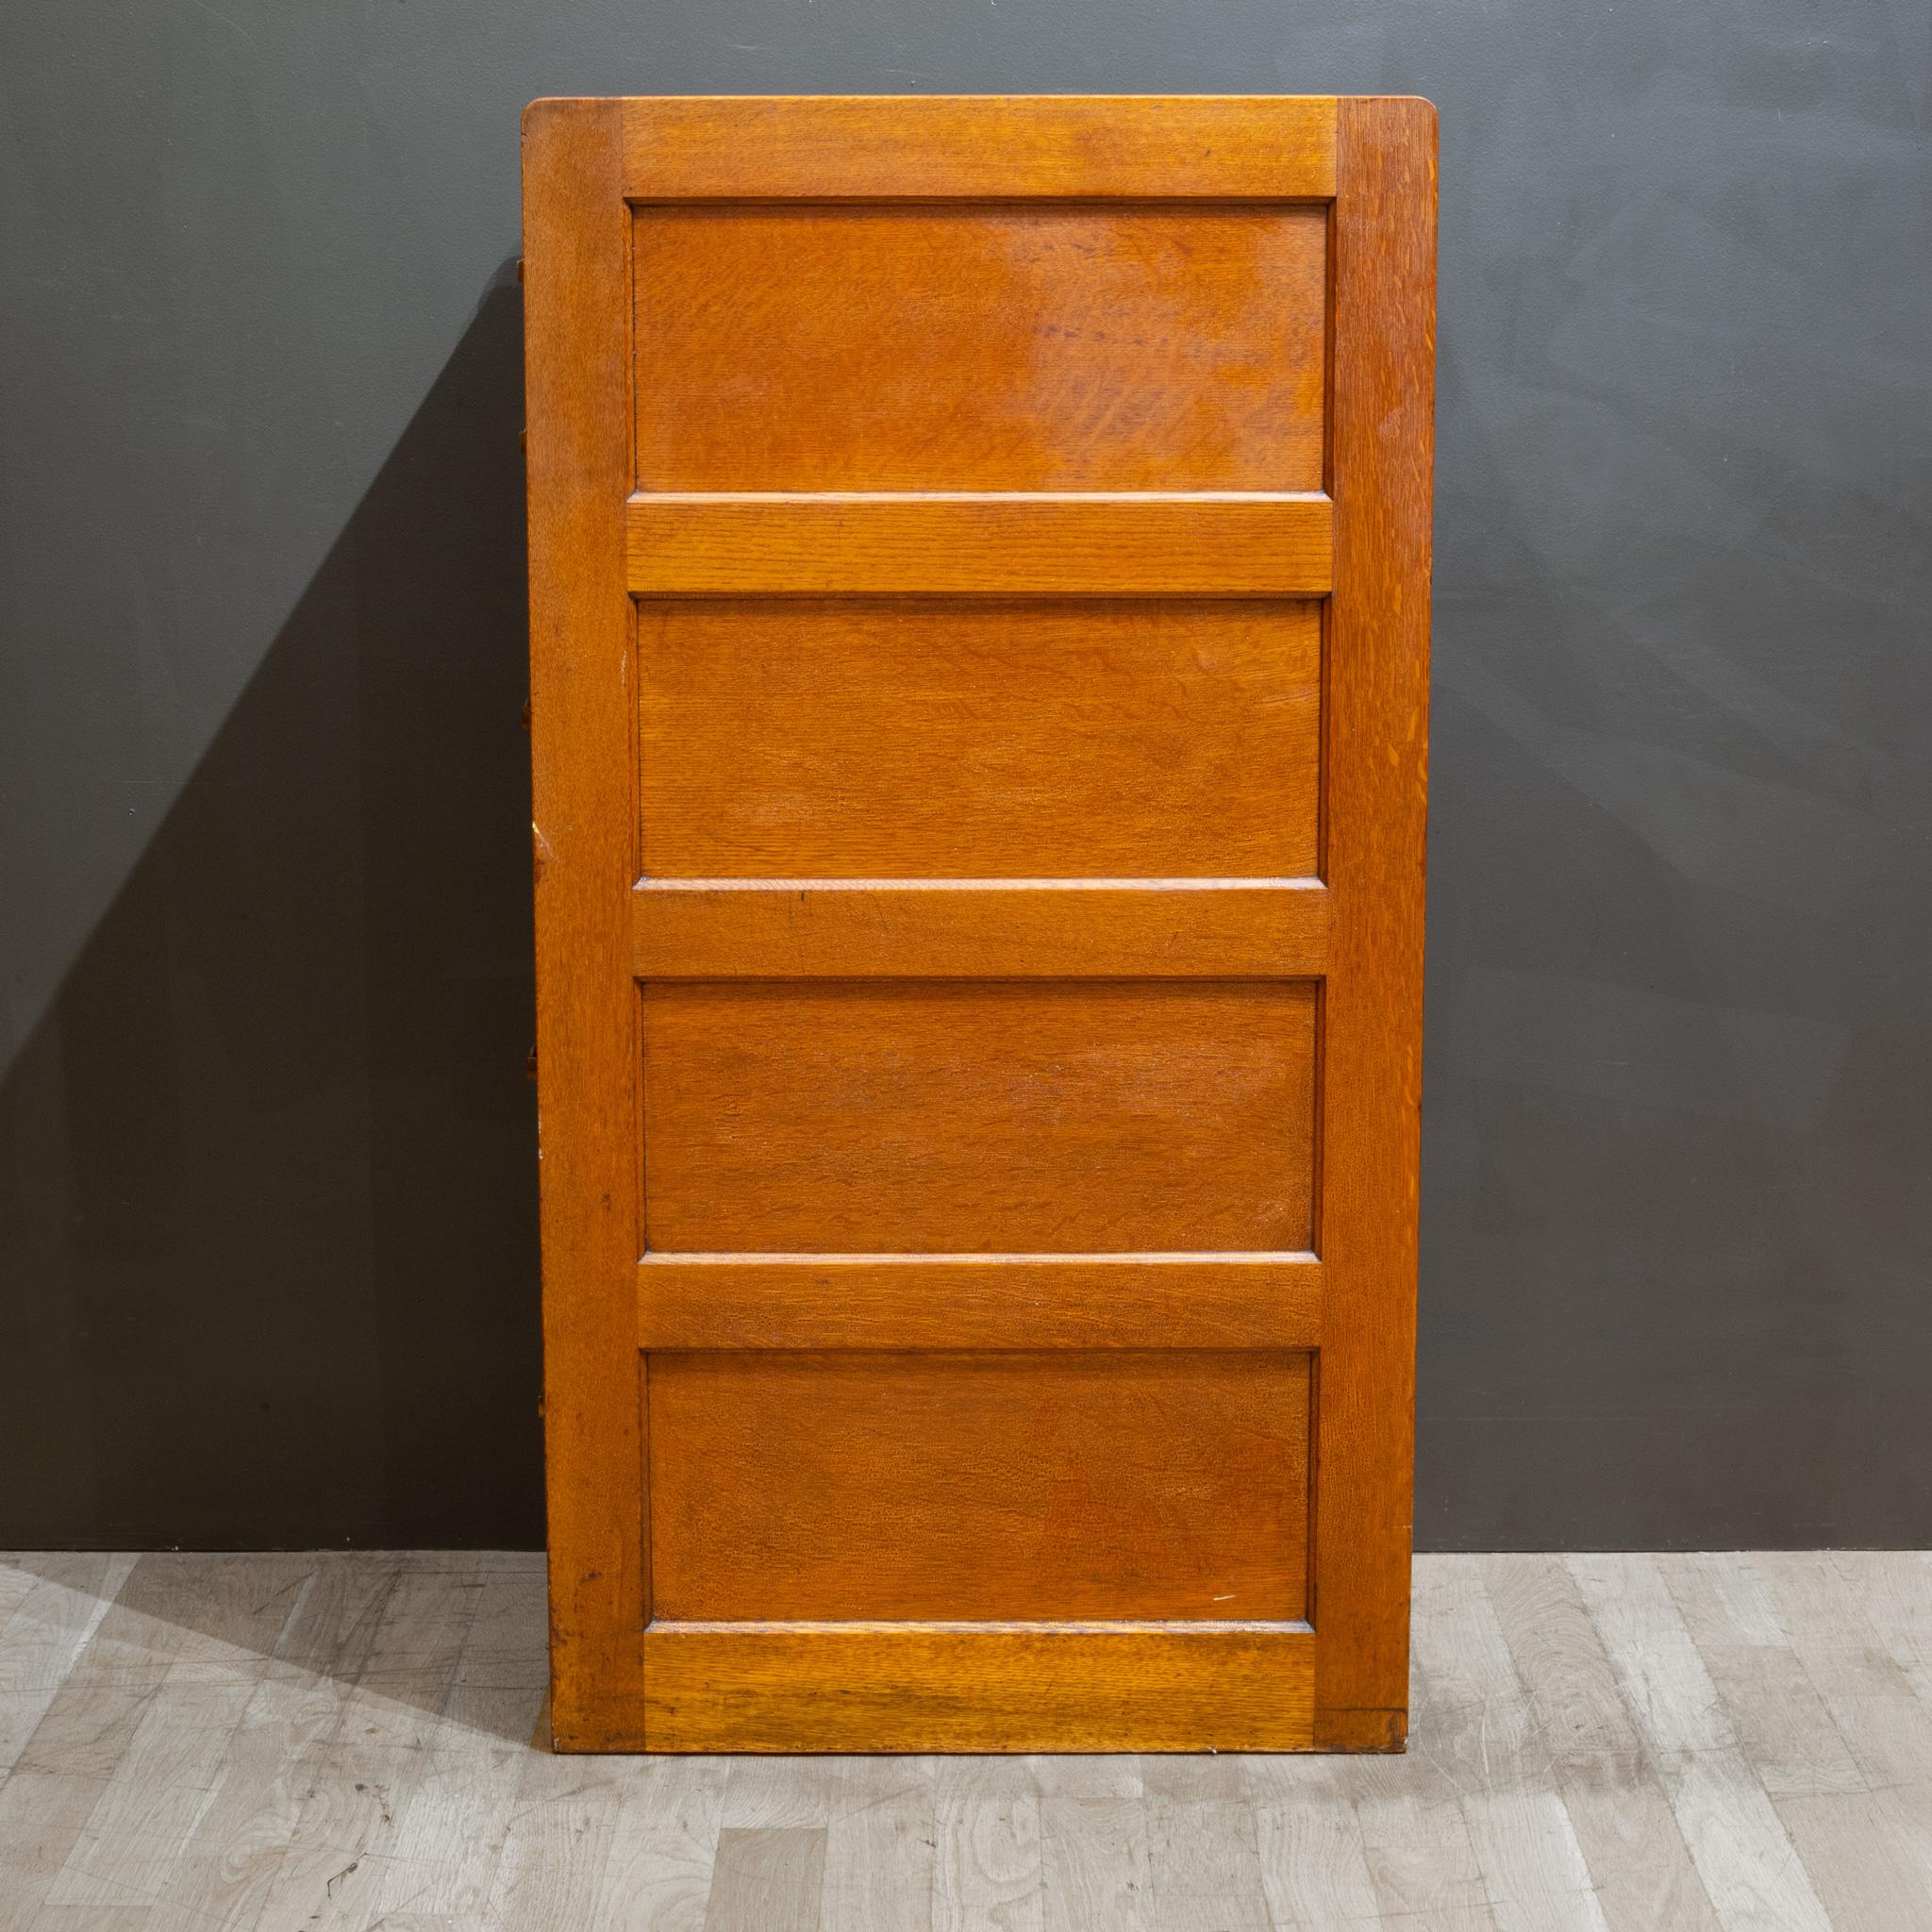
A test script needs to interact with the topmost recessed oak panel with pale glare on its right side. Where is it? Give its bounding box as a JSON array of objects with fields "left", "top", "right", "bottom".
[{"left": 632, "top": 201, "right": 1327, "bottom": 491}]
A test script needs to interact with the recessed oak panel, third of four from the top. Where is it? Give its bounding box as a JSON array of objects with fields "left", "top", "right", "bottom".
[{"left": 643, "top": 979, "right": 1314, "bottom": 1254}]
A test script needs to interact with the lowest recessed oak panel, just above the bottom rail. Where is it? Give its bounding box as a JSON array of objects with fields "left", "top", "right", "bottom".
[{"left": 647, "top": 1353, "right": 1307, "bottom": 1621}]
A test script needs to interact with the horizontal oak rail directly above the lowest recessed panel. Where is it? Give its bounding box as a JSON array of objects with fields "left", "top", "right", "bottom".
[{"left": 638, "top": 1254, "right": 1322, "bottom": 1351}]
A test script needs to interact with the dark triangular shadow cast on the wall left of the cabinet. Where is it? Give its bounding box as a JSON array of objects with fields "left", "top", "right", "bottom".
[{"left": 0, "top": 275, "right": 542, "bottom": 1547}]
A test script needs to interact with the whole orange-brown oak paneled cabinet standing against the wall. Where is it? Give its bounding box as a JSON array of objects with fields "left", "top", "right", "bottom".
[{"left": 524, "top": 96, "right": 1436, "bottom": 1750}]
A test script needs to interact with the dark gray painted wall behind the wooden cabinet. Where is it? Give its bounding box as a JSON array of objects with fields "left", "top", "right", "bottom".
[{"left": 0, "top": 0, "right": 1932, "bottom": 1547}]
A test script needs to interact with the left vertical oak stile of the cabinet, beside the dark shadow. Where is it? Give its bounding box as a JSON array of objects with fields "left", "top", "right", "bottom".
[{"left": 524, "top": 100, "right": 649, "bottom": 1744}]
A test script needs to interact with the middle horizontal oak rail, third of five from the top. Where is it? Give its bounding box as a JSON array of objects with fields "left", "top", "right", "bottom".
[{"left": 632, "top": 879, "right": 1327, "bottom": 979}]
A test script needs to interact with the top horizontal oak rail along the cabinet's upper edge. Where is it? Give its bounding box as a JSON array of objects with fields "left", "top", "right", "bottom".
[{"left": 625, "top": 94, "right": 1335, "bottom": 201}]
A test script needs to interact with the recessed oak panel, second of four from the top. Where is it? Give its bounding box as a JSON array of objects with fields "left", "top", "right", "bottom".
[{"left": 638, "top": 599, "right": 1322, "bottom": 879}]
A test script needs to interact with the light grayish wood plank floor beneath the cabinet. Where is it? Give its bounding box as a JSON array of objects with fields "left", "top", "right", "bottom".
[{"left": 0, "top": 1554, "right": 1932, "bottom": 1932}]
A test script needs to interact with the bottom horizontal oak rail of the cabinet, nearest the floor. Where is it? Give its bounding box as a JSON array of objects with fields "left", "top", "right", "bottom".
[{"left": 643, "top": 1624, "right": 1312, "bottom": 1753}]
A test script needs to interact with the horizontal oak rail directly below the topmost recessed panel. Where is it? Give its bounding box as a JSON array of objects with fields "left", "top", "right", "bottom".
[{"left": 626, "top": 491, "right": 1335, "bottom": 597}]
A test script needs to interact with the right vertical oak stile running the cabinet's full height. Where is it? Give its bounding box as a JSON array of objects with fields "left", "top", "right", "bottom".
[{"left": 1316, "top": 98, "right": 1436, "bottom": 1748}]
